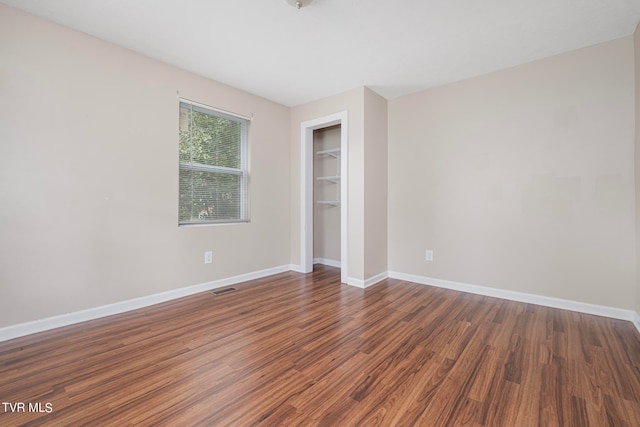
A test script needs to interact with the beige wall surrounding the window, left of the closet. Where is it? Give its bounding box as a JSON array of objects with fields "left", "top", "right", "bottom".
[{"left": 0, "top": 5, "right": 290, "bottom": 327}]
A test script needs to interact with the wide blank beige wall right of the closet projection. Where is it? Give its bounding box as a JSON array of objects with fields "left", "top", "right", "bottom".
[{"left": 389, "top": 37, "right": 636, "bottom": 309}]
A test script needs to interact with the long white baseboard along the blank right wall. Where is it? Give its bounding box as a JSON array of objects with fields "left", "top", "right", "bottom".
[{"left": 389, "top": 271, "right": 640, "bottom": 322}]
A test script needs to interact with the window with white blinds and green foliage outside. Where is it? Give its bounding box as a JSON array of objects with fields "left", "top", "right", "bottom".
[{"left": 178, "top": 101, "right": 249, "bottom": 225}]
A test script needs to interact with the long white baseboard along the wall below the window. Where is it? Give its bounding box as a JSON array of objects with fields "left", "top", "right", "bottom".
[{"left": 0, "top": 265, "right": 293, "bottom": 342}]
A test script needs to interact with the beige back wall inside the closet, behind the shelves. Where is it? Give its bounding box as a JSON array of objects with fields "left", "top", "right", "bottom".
[{"left": 313, "top": 125, "right": 340, "bottom": 262}]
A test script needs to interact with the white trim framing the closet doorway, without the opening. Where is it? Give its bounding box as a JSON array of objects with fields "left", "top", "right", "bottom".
[{"left": 300, "top": 111, "right": 349, "bottom": 283}]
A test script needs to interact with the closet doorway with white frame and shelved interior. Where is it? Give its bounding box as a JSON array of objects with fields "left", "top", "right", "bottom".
[{"left": 300, "top": 111, "right": 348, "bottom": 283}]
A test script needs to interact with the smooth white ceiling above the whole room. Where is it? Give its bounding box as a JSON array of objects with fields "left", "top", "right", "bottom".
[{"left": 0, "top": 0, "right": 640, "bottom": 106}]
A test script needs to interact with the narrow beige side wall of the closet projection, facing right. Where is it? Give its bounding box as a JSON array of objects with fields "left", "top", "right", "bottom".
[{"left": 364, "top": 88, "right": 388, "bottom": 279}]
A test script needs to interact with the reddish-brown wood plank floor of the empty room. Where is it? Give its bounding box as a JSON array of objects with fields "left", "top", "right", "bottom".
[{"left": 0, "top": 266, "right": 640, "bottom": 427}]
